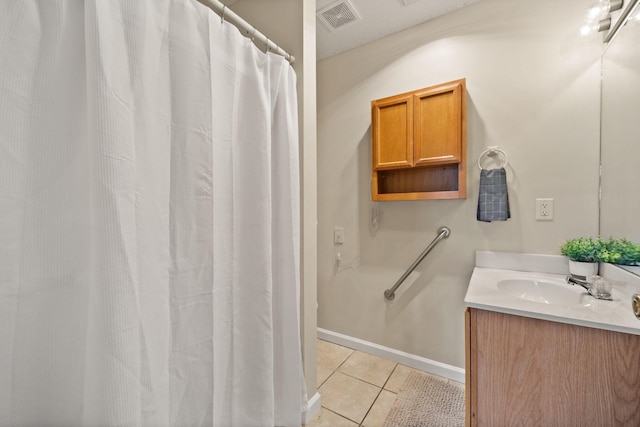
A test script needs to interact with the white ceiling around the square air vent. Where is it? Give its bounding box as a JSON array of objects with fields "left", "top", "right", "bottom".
[{"left": 316, "top": 0, "right": 479, "bottom": 60}]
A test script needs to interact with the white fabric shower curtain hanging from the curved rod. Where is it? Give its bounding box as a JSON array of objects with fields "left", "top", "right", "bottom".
[{"left": 0, "top": 0, "right": 306, "bottom": 427}]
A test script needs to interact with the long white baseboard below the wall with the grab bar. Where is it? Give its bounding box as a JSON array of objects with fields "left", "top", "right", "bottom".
[{"left": 318, "top": 328, "right": 465, "bottom": 383}]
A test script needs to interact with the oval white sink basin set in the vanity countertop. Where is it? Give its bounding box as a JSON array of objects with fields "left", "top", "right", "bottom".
[{"left": 497, "top": 279, "right": 590, "bottom": 305}]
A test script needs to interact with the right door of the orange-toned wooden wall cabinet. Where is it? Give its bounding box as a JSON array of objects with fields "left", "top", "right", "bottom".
[{"left": 413, "top": 81, "right": 464, "bottom": 166}]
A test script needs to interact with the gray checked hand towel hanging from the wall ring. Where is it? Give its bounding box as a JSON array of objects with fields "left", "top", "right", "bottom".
[{"left": 477, "top": 168, "right": 511, "bottom": 222}]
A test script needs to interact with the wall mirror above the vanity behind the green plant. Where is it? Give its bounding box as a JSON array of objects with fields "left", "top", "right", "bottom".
[{"left": 600, "top": 1, "right": 640, "bottom": 272}]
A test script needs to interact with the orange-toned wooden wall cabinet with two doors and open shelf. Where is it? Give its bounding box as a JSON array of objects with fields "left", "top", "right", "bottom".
[{"left": 371, "top": 79, "right": 467, "bottom": 200}]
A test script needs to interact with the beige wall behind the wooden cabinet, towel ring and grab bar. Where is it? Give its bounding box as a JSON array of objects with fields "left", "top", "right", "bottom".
[{"left": 317, "top": 0, "right": 599, "bottom": 367}]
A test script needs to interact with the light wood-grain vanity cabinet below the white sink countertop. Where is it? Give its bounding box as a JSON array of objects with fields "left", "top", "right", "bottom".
[{"left": 465, "top": 308, "right": 640, "bottom": 427}]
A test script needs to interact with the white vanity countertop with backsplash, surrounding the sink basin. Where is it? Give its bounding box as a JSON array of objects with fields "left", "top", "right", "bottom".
[{"left": 464, "top": 252, "right": 640, "bottom": 335}]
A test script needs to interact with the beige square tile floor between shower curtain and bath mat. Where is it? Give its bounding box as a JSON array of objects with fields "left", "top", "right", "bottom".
[{"left": 307, "top": 340, "right": 464, "bottom": 427}]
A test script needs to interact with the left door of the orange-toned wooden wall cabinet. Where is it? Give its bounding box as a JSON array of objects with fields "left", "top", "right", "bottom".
[{"left": 371, "top": 94, "right": 413, "bottom": 170}]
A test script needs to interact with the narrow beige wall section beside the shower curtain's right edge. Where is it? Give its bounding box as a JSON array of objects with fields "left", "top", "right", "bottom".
[{"left": 231, "top": 0, "right": 317, "bottom": 398}]
